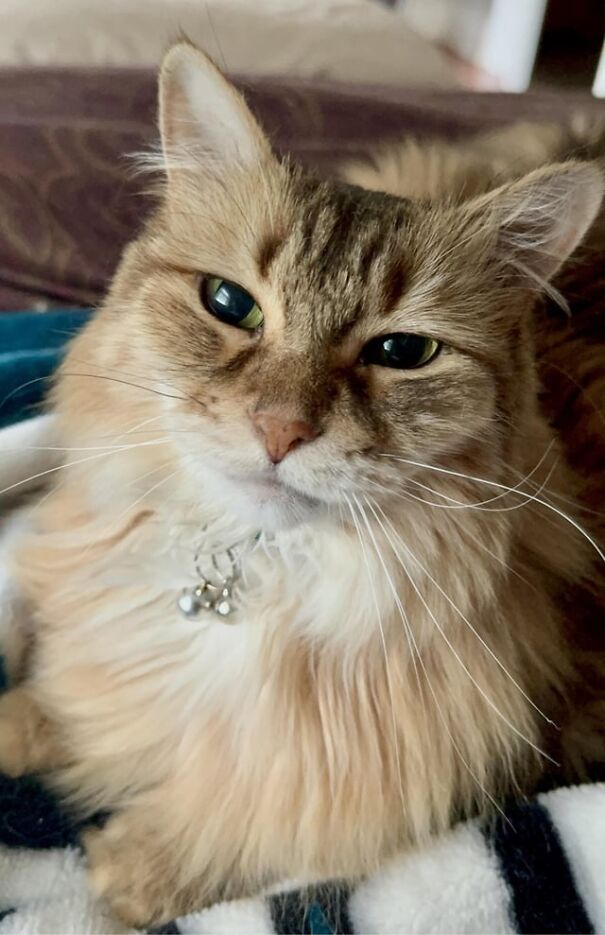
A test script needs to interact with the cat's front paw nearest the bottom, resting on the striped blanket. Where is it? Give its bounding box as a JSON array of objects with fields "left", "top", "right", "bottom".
[{"left": 83, "top": 812, "right": 181, "bottom": 928}]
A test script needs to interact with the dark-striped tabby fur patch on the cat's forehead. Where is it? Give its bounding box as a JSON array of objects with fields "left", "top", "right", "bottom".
[{"left": 259, "top": 174, "right": 413, "bottom": 336}]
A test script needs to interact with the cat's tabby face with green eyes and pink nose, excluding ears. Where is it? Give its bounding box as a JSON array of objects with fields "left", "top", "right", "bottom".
[{"left": 134, "top": 169, "right": 502, "bottom": 525}]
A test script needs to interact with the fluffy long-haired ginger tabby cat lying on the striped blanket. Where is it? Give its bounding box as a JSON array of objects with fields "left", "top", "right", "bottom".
[{"left": 0, "top": 42, "right": 604, "bottom": 925}]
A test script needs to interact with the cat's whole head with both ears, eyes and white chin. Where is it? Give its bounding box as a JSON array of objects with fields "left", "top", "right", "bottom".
[{"left": 75, "top": 43, "right": 602, "bottom": 528}]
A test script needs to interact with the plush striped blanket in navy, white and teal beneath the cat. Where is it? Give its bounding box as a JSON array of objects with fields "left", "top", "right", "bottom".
[{"left": 0, "top": 312, "right": 605, "bottom": 935}]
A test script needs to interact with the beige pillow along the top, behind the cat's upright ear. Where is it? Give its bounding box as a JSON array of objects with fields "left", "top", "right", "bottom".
[{"left": 0, "top": 0, "right": 457, "bottom": 88}]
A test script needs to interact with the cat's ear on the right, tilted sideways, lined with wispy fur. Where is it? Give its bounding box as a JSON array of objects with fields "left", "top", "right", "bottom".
[{"left": 468, "top": 162, "right": 605, "bottom": 285}]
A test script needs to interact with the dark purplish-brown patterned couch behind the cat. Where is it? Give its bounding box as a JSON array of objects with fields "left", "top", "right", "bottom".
[{"left": 0, "top": 69, "right": 605, "bottom": 310}]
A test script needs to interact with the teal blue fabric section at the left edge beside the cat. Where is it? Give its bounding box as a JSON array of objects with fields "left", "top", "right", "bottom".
[{"left": 0, "top": 309, "right": 90, "bottom": 428}]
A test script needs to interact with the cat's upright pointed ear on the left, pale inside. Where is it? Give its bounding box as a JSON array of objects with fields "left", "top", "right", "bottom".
[{"left": 159, "top": 42, "right": 271, "bottom": 174}]
